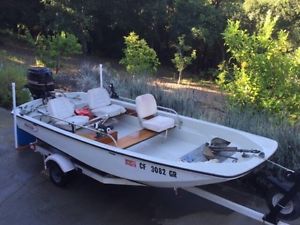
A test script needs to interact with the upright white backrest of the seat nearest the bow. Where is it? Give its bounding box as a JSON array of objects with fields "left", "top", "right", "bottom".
[{"left": 135, "top": 94, "right": 157, "bottom": 119}]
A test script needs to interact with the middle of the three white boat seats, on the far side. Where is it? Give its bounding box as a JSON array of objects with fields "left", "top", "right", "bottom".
[{"left": 87, "top": 88, "right": 126, "bottom": 117}]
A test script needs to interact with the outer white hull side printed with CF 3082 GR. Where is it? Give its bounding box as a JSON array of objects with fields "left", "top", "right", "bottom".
[{"left": 18, "top": 118, "right": 238, "bottom": 187}]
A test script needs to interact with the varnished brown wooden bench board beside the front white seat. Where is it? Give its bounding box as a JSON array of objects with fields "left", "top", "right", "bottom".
[{"left": 113, "top": 129, "right": 159, "bottom": 148}]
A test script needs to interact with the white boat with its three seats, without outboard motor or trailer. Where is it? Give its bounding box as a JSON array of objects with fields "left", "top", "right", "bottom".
[{"left": 15, "top": 71, "right": 277, "bottom": 188}]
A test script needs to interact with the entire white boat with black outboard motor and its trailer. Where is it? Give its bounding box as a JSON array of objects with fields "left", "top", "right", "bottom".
[{"left": 12, "top": 67, "right": 300, "bottom": 224}]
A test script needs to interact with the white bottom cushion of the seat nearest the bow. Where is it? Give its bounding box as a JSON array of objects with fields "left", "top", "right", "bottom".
[{"left": 142, "top": 116, "right": 175, "bottom": 132}]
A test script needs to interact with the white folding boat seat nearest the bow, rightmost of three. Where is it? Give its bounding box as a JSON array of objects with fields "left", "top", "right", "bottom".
[{"left": 135, "top": 94, "right": 175, "bottom": 132}]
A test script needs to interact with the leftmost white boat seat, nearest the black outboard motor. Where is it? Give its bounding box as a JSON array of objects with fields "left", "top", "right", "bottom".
[{"left": 47, "top": 97, "right": 89, "bottom": 130}]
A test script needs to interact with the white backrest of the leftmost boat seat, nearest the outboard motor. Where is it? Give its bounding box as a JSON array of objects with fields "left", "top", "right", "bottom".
[{"left": 47, "top": 97, "right": 74, "bottom": 119}]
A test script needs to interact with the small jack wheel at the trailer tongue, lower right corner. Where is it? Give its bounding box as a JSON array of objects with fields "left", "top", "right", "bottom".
[{"left": 267, "top": 190, "right": 300, "bottom": 220}]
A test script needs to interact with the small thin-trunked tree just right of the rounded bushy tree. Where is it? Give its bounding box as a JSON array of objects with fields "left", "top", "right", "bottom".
[{"left": 172, "top": 35, "right": 197, "bottom": 84}]
